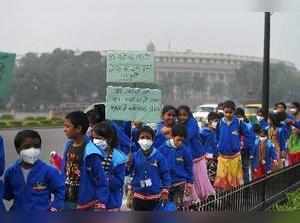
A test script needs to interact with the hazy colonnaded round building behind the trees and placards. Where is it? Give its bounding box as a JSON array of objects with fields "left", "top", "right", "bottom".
[{"left": 154, "top": 50, "right": 296, "bottom": 107}]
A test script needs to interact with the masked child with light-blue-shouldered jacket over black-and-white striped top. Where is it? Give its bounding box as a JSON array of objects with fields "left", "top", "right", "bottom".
[{"left": 92, "top": 121, "right": 127, "bottom": 211}]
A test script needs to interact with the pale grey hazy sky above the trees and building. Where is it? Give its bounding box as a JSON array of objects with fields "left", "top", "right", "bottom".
[{"left": 0, "top": 0, "right": 300, "bottom": 68}]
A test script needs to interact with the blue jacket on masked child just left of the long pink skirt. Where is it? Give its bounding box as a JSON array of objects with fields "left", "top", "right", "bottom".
[{"left": 158, "top": 141, "right": 193, "bottom": 184}]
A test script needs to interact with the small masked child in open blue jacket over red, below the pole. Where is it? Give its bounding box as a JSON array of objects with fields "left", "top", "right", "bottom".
[{"left": 252, "top": 126, "right": 277, "bottom": 180}]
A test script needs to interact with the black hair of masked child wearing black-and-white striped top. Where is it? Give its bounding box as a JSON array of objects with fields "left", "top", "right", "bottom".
[{"left": 93, "top": 121, "right": 118, "bottom": 149}]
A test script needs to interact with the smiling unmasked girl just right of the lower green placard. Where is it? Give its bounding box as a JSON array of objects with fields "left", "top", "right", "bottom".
[{"left": 153, "top": 105, "right": 176, "bottom": 148}]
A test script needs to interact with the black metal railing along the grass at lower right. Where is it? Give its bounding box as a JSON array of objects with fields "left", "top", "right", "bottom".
[{"left": 197, "top": 164, "right": 300, "bottom": 212}]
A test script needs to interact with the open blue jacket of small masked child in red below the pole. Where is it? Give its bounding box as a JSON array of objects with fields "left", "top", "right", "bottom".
[{"left": 252, "top": 137, "right": 277, "bottom": 172}]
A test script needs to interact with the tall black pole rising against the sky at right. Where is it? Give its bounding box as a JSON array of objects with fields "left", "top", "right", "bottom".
[{"left": 262, "top": 12, "right": 271, "bottom": 118}]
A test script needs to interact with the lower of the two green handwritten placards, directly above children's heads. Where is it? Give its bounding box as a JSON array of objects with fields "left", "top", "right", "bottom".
[{"left": 105, "top": 86, "right": 161, "bottom": 122}]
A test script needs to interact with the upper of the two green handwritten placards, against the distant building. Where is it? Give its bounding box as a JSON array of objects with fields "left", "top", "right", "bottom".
[{"left": 106, "top": 51, "right": 155, "bottom": 83}]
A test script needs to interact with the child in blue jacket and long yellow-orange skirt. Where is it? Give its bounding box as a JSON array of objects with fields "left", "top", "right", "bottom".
[{"left": 214, "top": 101, "right": 250, "bottom": 190}]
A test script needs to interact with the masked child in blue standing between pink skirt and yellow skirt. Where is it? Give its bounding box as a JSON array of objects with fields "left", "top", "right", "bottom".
[{"left": 200, "top": 112, "right": 219, "bottom": 184}]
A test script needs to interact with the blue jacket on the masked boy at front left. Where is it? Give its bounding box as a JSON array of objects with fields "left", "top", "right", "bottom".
[{"left": 4, "top": 160, "right": 65, "bottom": 212}]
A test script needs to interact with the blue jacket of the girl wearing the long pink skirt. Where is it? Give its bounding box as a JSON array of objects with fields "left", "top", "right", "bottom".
[{"left": 184, "top": 116, "right": 205, "bottom": 159}]
